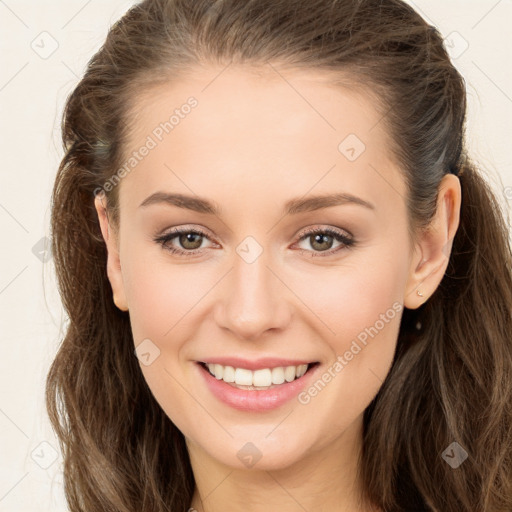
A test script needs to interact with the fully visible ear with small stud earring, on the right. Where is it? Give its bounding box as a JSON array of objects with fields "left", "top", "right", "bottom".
[{"left": 404, "top": 174, "right": 461, "bottom": 309}]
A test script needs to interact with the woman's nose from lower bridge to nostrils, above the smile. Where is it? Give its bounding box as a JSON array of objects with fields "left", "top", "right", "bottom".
[{"left": 215, "top": 248, "right": 292, "bottom": 340}]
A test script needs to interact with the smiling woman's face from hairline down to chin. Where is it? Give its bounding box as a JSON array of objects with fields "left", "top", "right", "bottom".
[{"left": 96, "top": 67, "right": 440, "bottom": 469}]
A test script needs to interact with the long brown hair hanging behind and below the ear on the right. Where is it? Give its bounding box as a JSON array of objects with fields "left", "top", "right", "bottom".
[{"left": 363, "top": 161, "right": 512, "bottom": 512}]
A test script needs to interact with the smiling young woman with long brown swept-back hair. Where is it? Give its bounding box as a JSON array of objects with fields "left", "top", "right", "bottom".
[{"left": 47, "top": 0, "right": 512, "bottom": 512}]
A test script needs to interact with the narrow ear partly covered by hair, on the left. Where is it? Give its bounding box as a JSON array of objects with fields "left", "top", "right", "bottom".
[{"left": 94, "top": 194, "right": 128, "bottom": 311}]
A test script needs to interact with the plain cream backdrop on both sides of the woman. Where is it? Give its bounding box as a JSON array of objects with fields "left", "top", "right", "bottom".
[{"left": 0, "top": 0, "right": 512, "bottom": 512}]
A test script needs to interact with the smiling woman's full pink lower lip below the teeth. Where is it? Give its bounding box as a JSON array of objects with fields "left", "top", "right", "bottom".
[{"left": 197, "top": 363, "right": 319, "bottom": 411}]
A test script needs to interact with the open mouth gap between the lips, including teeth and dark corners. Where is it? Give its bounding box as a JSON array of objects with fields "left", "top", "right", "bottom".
[{"left": 198, "top": 361, "right": 320, "bottom": 391}]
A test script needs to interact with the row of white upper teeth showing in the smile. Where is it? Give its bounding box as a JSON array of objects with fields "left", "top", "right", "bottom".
[{"left": 203, "top": 363, "right": 308, "bottom": 388}]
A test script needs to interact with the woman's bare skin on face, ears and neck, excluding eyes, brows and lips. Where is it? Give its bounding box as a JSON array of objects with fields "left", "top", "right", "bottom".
[{"left": 95, "top": 66, "right": 461, "bottom": 512}]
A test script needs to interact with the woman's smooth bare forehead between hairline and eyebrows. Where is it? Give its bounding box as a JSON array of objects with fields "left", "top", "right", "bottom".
[{"left": 121, "top": 66, "right": 403, "bottom": 216}]
